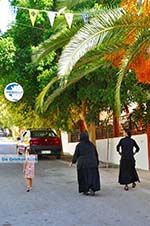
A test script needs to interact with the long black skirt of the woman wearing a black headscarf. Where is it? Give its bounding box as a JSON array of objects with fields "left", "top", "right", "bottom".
[{"left": 77, "top": 168, "right": 100, "bottom": 193}]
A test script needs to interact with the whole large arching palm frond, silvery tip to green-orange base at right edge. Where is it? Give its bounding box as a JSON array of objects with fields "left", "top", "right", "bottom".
[{"left": 58, "top": 8, "right": 150, "bottom": 76}]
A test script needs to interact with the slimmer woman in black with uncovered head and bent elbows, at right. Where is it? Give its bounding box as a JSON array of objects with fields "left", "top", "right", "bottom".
[{"left": 117, "top": 129, "right": 140, "bottom": 191}]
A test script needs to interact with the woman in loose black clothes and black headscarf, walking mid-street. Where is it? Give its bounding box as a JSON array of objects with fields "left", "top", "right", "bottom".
[{"left": 71, "top": 132, "right": 100, "bottom": 195}]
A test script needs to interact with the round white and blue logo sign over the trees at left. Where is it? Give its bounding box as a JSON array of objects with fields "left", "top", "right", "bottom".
[{"left": 4, "top": 82, "right": 23, "bottom": 102}]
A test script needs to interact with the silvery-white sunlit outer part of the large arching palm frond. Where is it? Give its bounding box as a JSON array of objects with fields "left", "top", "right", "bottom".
[{"left": 58, "top": 8, "right": 125, "bottom": 76}]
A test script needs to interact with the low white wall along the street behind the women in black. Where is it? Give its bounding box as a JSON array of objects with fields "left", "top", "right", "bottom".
[{"left": 61, "top": 132, "right": 149, "bottom": 170}]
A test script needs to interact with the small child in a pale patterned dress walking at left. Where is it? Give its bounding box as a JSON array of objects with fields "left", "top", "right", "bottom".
[{"left": 23, "top": 149, "right": 35, "bottom": 192}]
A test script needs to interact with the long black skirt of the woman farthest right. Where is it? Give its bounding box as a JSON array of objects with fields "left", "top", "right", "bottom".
[{"left": 119, "top": 159, "right": 140, "bottom": 185}]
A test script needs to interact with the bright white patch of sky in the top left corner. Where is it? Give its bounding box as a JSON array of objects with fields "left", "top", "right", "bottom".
[{"left": 0, "top": 0, "right": 12, "bottom": 32}]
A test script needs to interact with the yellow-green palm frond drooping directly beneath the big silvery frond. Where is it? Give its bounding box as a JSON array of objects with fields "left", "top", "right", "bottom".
[{"left": 36, "top": 40, "right": 126, "bottom": 113}]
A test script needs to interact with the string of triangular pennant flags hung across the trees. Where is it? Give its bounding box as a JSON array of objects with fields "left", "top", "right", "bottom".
[{"left": 12, "top": 6, "right": 89, "bottom": 28}]
